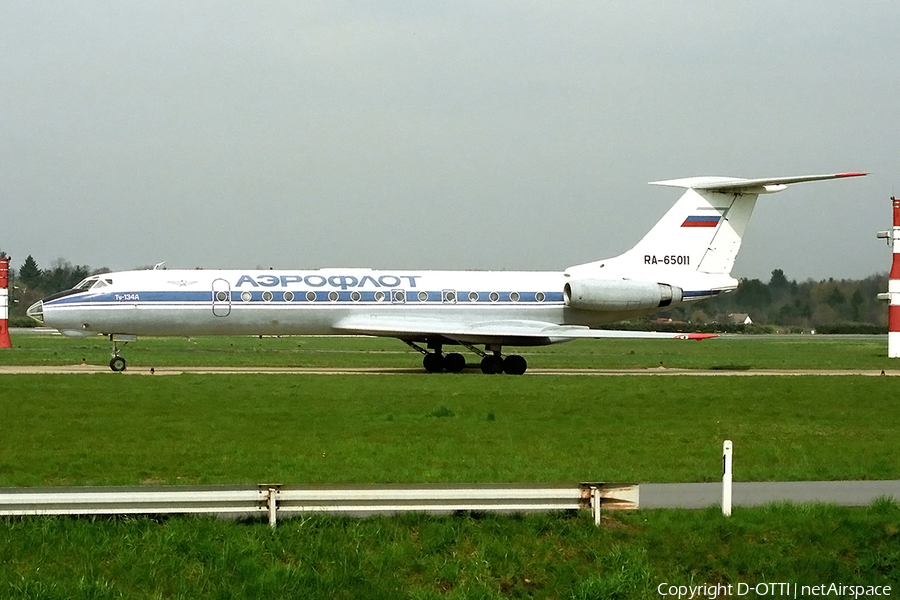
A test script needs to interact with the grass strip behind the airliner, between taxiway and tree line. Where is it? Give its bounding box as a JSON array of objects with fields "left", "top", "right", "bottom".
[{"left": 0, "top": 334, "right": 898, "bottom": 370}]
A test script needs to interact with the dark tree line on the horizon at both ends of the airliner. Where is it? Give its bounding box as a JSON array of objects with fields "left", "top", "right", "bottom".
[{"left": 0, "top": 251, "right": 888, "bottom": 333}]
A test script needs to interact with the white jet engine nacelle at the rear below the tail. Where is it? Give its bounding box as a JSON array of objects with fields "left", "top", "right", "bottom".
[{"left": 563, "top": 279, "right": 682, "bottom": 312}]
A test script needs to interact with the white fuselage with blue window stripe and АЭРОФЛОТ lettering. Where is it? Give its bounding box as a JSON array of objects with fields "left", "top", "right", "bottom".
[{"left": 31, "top": 269, "right": 664, "bottom": 345}]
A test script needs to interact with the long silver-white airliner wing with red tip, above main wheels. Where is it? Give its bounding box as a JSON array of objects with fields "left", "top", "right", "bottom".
[{"left": 334, "top": 315, "right": 717, "bottom": 345}]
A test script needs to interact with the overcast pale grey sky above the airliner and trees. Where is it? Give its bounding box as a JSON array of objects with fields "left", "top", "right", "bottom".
[{"left": 0, "top": 0, "right": 900, "bottom": 280}]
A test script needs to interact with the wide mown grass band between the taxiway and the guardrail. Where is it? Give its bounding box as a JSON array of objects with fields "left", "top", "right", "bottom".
[{"left": 0, "top": 373, "right": 900, "bottom": 486}]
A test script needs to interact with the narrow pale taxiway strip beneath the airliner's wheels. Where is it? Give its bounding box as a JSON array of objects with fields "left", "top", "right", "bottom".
[{"left": 0, "top": 365, "right": 900, "bottom": 377}]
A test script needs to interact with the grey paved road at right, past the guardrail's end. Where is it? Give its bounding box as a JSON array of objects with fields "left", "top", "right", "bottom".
[{"left": 640, "top": 481, "right": 900, "bottom": 509}]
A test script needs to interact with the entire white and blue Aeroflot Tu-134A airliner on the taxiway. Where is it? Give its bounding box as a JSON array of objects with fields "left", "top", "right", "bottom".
[{"left": 28, "top": 173, "right": 865, "bottom": 375}]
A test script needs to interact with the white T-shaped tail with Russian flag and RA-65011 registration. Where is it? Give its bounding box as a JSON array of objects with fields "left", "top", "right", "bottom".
[{"left": 573, "top": 173, "right": 866, "bottom": 275}]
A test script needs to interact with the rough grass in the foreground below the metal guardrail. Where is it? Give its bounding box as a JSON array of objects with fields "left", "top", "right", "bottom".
[{"left": 0, "top": 502, "right": 900, "bottom": 600}]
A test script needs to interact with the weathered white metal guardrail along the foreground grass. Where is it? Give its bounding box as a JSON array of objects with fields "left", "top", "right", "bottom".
[{"left": 0, "top": 483, "right": 640, "bottom": 527}]
